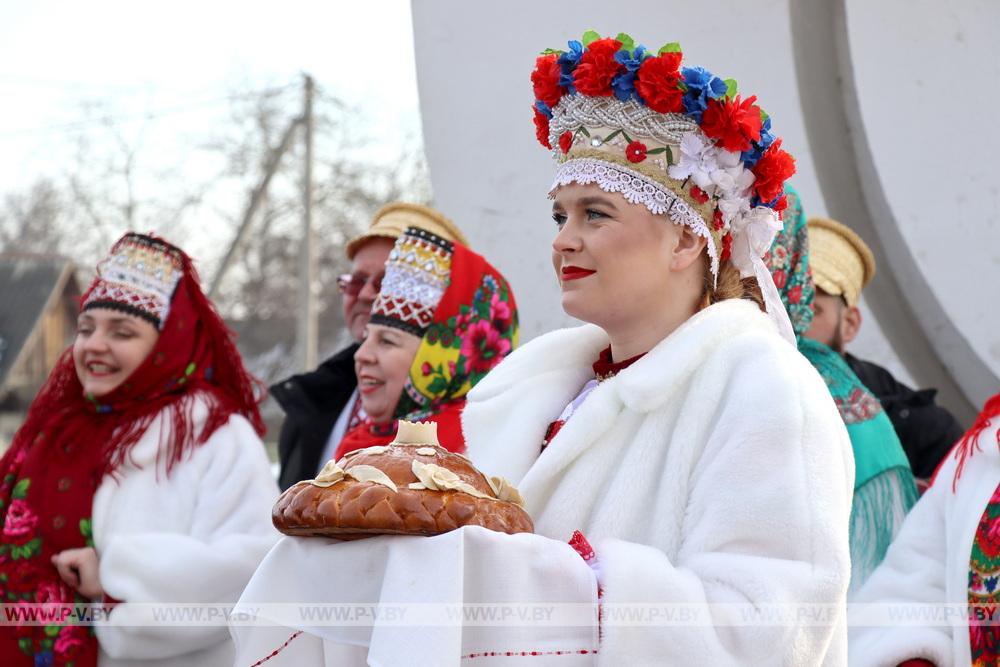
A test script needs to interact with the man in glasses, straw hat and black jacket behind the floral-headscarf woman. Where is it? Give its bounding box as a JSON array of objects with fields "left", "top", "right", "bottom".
[{"left": 271, "top": 202, "right": 468, "bottom": 490}]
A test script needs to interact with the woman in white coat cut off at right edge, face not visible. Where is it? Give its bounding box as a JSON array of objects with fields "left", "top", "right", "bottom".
[{"left": 850, "top": 394, "right": 1000, "bottom": 667}]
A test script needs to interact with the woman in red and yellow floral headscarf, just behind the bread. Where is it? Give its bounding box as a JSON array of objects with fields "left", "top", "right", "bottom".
[{"left": 334, "top": 227, "right": 518, "bottom": 459}]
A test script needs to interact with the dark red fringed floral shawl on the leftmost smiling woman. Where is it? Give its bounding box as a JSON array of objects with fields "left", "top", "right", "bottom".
[{"left": 0, "top": 253, "right": 264, "bottom": 667}]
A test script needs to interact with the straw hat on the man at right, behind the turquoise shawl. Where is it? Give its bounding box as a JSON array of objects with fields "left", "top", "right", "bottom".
[{"left": 808, "top": 218, "right": 875, "bottom": 306}]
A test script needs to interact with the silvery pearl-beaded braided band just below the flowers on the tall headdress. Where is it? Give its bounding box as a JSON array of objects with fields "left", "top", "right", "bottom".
[{"left": 549, "top": 95, "right": 698, "bottom": 146}]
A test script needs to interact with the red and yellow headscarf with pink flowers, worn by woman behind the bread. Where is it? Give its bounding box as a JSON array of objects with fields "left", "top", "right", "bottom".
[{"left": 334, "top": 236, "right": 518, "bottom": 459}]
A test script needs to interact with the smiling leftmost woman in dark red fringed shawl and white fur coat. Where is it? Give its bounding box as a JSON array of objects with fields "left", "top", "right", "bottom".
[{"left": 0, "top": 233, "right": 277, "bottom": 667}]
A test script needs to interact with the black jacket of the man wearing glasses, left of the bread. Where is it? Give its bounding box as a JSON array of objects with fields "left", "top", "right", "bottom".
[{"left": 271, "top": 343, "right": 359, "bottom": 491}]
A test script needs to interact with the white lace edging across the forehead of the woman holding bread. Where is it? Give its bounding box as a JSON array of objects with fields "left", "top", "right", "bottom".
[{"left": 549, "top": 158, "right": 719, "bottom": 277}]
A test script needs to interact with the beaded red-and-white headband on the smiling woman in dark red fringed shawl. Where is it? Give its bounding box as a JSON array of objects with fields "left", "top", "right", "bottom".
[{"left": 80, "top": 232, "right": 184, "bottom": 329}]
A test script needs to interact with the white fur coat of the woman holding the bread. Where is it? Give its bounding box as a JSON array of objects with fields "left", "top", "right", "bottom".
[{"left": 463, "top": 302, "right": 854, "bottom": 665}]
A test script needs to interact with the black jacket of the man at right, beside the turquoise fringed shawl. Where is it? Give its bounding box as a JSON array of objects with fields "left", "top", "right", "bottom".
[{"left": 844, "top": 354, "right": 965, "bottom": 479}]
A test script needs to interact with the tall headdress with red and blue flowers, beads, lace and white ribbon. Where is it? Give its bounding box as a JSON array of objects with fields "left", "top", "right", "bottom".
[{"left": 531, "top": 31, "right": 795, "bottom": 340}]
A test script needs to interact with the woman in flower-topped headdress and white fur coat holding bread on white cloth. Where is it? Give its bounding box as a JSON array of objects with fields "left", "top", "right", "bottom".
[{"left": 232, "top": 33, "right": 853, "bottom": 667}]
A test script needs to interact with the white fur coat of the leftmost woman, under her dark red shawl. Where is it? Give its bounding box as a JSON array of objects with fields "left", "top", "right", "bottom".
[{"left": 94, "top": 400, "right": 278, "bottom": 664}]
